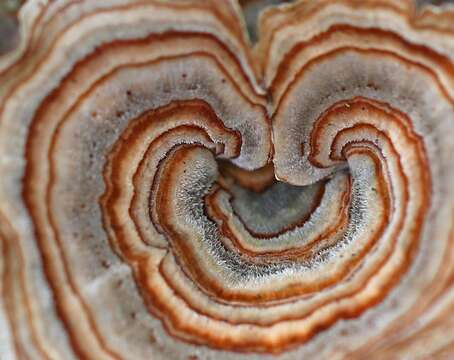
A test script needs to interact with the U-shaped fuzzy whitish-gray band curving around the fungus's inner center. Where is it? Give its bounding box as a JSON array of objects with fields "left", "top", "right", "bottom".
[{"left": 171, "top": 146, "right": 371, "bottom": 285}]
